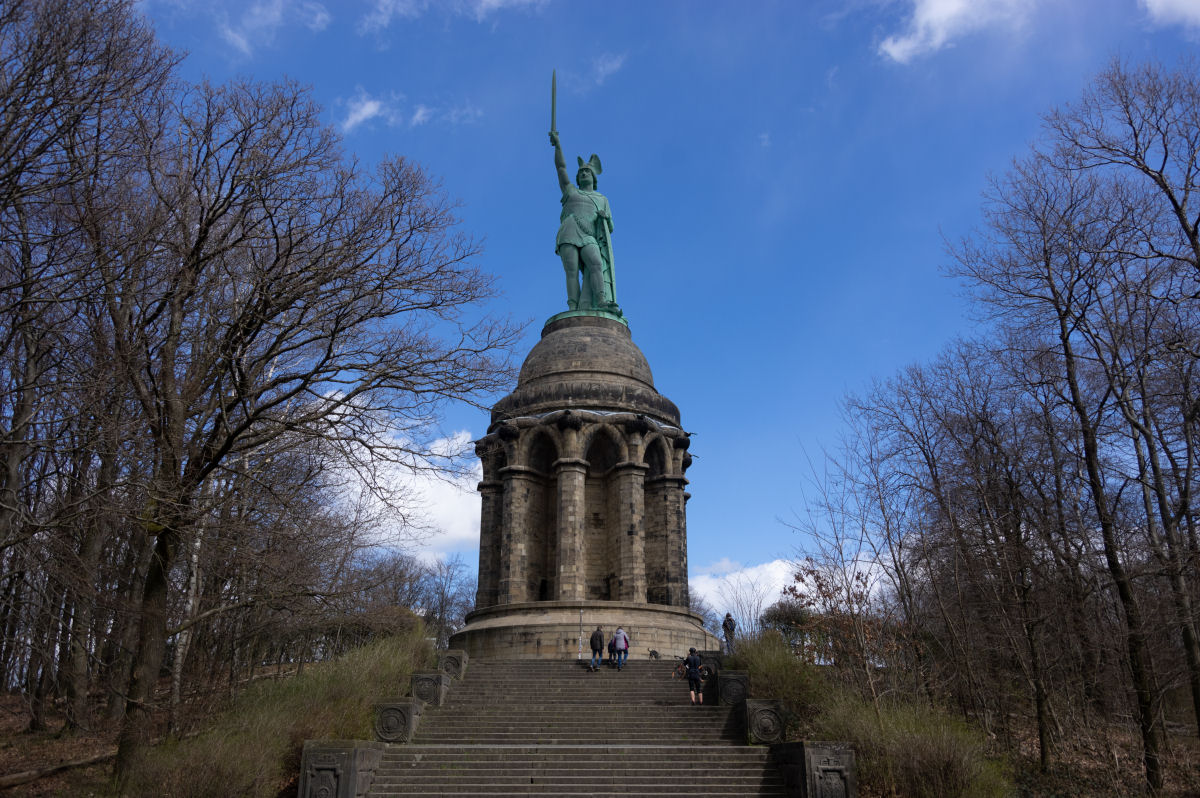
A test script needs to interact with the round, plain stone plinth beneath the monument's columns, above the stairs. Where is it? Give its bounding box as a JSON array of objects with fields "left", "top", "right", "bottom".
[{"left": 450, "top": 601, "right": 720, "bottom": 660}]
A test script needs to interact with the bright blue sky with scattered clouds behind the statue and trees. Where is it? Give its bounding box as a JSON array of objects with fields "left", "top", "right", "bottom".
[{"left": 140, "top": 0, "right": 1200, "bottom": 606}]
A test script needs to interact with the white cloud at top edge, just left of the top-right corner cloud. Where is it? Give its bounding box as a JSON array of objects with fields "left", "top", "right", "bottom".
[{"left": 880, "top": 0, "right": 1036, "bottom": 64}]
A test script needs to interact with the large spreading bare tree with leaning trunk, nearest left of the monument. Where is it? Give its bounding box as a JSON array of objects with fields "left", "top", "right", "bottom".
[{"left": 91, "top": 84, "right": 514, "bottom": 778}]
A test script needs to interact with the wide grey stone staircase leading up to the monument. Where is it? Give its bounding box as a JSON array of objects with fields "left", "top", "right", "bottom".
[{"left": 367, "top": 660, "right": 786, "bottom": 798}]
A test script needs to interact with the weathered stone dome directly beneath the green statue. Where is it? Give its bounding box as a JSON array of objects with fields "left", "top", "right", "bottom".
[{"left": 492, "top": 316, "right": 679, "bottom": 426}]
